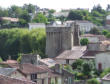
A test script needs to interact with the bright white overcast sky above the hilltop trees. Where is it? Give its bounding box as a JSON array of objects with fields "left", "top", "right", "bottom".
[{"left": 0, "top": 0, "right": 110, "bottom": 11}]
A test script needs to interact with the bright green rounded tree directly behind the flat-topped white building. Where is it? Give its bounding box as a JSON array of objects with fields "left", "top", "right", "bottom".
[{"left": 33, "top": 13, "right": 47, "bottom": 23}]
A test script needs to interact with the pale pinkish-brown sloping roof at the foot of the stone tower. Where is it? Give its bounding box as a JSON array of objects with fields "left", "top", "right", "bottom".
[{"left": 56, "top": 46, "right": 86, "bottom": 60}]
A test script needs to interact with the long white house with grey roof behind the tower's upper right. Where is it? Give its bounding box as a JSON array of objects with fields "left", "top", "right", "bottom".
[{"left": 64, "top": 20, "right": 97, "bottom": 32}]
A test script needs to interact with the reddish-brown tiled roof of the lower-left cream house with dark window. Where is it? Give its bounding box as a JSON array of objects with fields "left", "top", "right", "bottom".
[{"left": 10, "top": 63, "right": 47, "bottom": 74}]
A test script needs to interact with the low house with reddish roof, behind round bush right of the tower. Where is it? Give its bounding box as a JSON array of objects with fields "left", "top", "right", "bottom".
[{"left": 80, "top": 34, "right": 106, "bottom": 43}]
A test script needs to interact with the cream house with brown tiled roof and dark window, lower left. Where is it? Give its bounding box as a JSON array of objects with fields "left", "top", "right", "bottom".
[{"left": 9, "top": 63, "right": 48, "bottom": 84}]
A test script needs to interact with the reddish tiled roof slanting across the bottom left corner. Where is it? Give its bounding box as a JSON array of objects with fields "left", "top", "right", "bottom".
[{"left": 0, "top": 75, "right": 36, "bottom": 84}]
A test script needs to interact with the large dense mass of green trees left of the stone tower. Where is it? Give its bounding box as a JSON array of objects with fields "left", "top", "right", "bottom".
[{"left": 0, "top": 28, "right": 46, "bottom": 60}]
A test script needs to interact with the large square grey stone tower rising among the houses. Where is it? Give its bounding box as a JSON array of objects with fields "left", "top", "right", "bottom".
[{"left": 46, "top": 22, "right": 79, "bottom": 58}]
